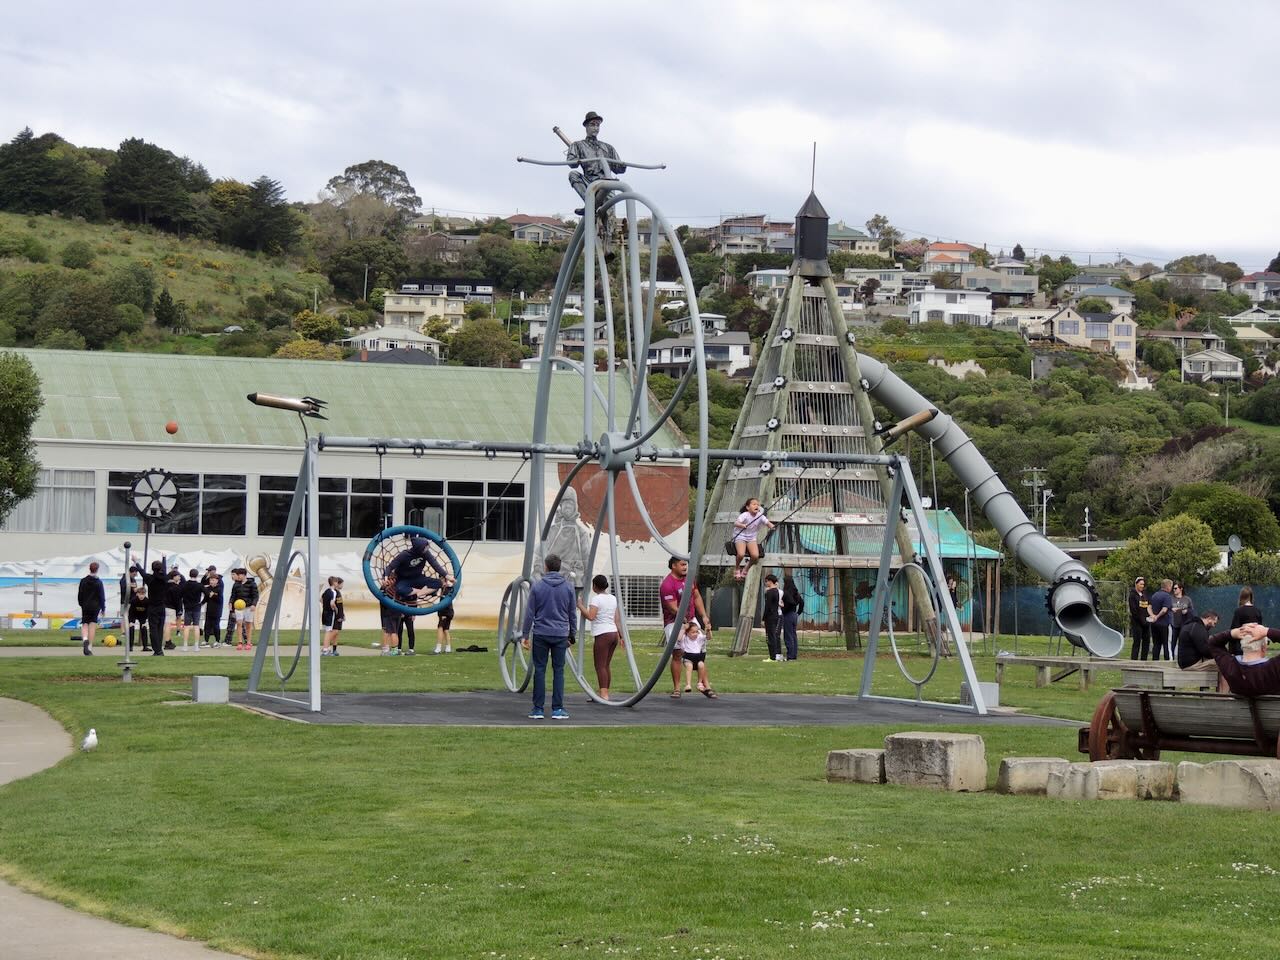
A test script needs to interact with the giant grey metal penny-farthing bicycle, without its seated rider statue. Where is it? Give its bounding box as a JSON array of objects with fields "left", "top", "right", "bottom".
[{"left": 498, "top": 150, "right": 708, "bottom": 707}]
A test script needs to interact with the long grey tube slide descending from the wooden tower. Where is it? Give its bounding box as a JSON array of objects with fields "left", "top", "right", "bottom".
[{"left": 858, "top": 353, "right": 1124, "bottom": 658}]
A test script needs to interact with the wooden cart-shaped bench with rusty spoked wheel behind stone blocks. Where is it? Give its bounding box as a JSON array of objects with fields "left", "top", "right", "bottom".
[{"left": 1078, "top": 687, "right": 1280, "bottom": 760}]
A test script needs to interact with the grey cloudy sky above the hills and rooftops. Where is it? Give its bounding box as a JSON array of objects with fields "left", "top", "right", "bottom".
[{"left": 0, "top": 0, "right": 1280, "bottom": 270}]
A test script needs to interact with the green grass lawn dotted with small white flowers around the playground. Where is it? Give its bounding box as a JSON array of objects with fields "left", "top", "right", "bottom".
[{"left": 0, "top": 631, "right": 1280, "bottom": 960}]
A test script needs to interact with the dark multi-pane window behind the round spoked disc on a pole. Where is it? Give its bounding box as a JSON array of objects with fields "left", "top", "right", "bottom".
[{"left": 106, "top": 470, "right": 248, "bottom": 536}]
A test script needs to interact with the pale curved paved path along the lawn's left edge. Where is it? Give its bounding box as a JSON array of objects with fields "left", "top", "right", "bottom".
[{"left": 0, "top": 701, "right": 243, "bottom": 960}]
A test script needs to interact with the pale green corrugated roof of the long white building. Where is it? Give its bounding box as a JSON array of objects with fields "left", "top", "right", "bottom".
[{"left": 17, "top": 349, "right": 681, "bottom": 448}]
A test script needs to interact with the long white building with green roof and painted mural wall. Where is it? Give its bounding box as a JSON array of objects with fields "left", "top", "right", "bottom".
[{"left": 0, "top": 349, "right": 689, "bottom": 627}]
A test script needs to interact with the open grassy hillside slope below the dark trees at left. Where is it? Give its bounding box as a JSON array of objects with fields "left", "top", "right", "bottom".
[{"left": 0, "top": 212, "right": 333, "bottom": 353}]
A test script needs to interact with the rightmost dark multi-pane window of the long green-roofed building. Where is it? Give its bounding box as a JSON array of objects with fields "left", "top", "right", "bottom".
[{"left": 404, "top": 480, "right": 525, "bottom": 543}]
